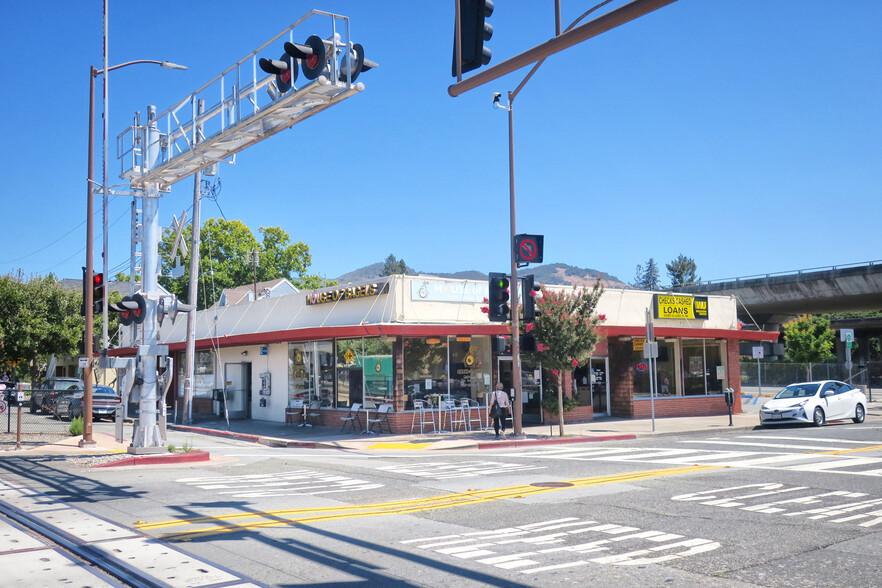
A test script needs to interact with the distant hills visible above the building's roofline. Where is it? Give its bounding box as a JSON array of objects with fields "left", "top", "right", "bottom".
[{"left": 336, "top": 263, "right": 629, "bottom": 288}]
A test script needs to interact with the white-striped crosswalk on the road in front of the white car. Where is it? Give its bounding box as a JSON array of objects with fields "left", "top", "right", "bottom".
[{"left": 505, "top": 435, "right": 882, "bottom": 476}]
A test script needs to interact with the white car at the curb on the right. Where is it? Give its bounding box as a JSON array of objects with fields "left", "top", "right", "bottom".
[{"left": 760, "top": 380, "right": 867, "bottom": 427}]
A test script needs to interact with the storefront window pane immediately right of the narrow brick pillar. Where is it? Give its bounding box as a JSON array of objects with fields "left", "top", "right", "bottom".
[{"left": 403, "top": 337, "right": 447, "bottom": 409}]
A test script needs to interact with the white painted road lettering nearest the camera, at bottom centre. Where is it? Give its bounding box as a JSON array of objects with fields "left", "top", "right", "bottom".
[{"left": 401, "top": 517, "right": 720, "bottom": 574}]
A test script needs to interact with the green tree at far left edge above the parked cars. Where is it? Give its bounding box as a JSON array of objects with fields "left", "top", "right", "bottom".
[{"left": 0, "top": 274, "right": 82, "bottom": 386}]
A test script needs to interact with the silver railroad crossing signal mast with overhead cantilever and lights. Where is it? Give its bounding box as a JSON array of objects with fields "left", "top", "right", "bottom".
[{"left": 112, "top": 10, "right": 378, "bottom": 453}]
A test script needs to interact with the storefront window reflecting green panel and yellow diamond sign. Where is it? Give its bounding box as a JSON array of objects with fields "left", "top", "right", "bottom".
[{"left": 336, "top": 337, "right": 394, "bottom": 408}]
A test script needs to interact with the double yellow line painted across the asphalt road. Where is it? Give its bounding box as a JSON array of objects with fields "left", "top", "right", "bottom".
[{"left": 135, "top": 465, "right": 719, "bottom": 541}]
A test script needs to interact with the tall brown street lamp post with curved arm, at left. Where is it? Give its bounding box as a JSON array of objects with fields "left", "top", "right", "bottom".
[{"left": 80, "top": 59, "right": 187, "bottom": 447}]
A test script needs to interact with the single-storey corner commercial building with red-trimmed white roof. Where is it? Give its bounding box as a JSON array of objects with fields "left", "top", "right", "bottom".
[{"left": 116, "top": 276, "right": 778, "bottom": 432}]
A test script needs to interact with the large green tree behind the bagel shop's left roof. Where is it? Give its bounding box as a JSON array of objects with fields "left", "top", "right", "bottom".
[{"left": 159, "top": 218, "right": 336, "bottom": 308}]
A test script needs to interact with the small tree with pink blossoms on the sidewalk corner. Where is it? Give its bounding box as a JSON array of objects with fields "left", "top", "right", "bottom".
[{"left": 524, "top": 280, "right": 606, "bottom": 436}]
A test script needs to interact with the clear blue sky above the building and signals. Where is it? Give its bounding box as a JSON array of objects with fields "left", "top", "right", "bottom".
[{"left": 0, "top": 0, "right": 882, "bottom": 282}]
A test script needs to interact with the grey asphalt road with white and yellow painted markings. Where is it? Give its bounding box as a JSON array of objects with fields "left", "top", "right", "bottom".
[{"left": 0, "top": 418, "right": 882, "bottom": 587}]
